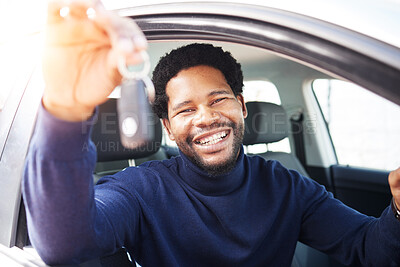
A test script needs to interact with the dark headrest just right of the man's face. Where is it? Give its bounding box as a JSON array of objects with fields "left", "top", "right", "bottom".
[{"left": 243, "top": 102, "right": 289, "bottom": 145}]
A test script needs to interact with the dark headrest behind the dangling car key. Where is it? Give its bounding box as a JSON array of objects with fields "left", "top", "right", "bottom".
[{"left": 92, "top": 98, "right": 162, "bottom": 162}]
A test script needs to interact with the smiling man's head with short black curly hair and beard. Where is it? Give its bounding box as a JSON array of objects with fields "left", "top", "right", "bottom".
[{"left": 154, "top": 48, "right": 247, "bottom": 175}]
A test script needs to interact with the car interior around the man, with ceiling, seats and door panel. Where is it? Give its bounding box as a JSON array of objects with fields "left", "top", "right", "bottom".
[{"left": 7, "top": 38, "right": 391, "bottom": 267}]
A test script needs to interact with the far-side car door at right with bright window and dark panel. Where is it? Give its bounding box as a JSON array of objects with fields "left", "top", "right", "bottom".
[{"left": 310, "top": 79, "right": 400, "bottom": 220}]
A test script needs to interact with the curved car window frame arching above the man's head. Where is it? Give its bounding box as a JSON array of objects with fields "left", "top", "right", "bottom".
[{"left": 119, "top": 3, "right": 400, "bottom": 104}]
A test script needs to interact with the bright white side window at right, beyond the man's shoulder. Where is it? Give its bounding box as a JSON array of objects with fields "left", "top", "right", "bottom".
[{"left": 312, "top": 79, "right": 400, "bottom": 170}]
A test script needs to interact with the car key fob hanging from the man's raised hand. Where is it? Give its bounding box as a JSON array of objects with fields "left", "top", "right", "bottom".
[{"left": 117, "top": 79, "right": 155, "bottom": 149}]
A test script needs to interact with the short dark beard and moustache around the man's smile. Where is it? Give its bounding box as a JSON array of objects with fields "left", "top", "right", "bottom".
[{"left": 176, "top": 122, "right": 244, "bottom": 176}]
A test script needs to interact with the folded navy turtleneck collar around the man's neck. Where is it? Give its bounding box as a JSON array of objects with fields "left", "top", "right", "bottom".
[{"left": 179, "top": 146, "right": 245, "bottom": 195}]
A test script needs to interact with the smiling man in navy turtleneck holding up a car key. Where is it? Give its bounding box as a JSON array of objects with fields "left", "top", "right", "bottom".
[{"left": 23, "top": 2, "right": 400, "bottom": 266}]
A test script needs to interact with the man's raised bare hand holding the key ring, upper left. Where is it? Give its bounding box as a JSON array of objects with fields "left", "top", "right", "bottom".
[{"left": 43, "top": 0, "right": 147, "bottom": 121}]
